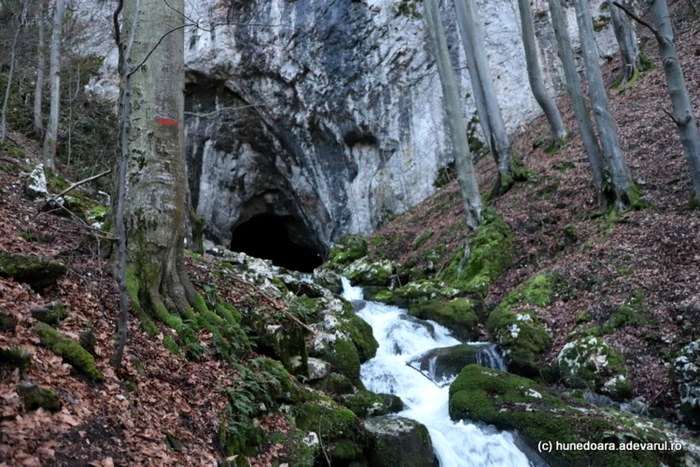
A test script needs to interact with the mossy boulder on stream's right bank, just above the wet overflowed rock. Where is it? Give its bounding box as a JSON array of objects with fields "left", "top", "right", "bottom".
[{"left": 408, "top": 298, "right": 484, "bottom": 341}]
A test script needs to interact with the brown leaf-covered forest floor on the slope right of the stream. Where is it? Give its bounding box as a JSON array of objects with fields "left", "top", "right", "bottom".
[{"left": 370, "top": 2, "right": 700, "bottom": 417}]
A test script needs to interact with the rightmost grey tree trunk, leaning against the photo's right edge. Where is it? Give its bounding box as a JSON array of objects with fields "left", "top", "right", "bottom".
[{"left": 651, "top": 0, "right": 700, "bottom": 205}]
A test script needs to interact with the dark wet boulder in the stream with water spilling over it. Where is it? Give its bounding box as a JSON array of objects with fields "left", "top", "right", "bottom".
[{"left": 408, "top": 343, "right": 495, "bottom": 383}]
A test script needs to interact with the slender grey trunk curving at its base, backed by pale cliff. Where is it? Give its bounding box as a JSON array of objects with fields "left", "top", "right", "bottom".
[{"left": 518, "top": 0, "right": 566, "bottom": 147}]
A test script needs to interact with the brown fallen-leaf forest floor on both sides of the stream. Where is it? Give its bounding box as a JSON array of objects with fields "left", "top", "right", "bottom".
[{"left": 0, "top": 0, "right": 700, "bottom": 467}]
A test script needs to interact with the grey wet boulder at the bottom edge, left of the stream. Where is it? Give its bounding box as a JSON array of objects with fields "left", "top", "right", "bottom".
[{"left": 365, "top": 415, "right": 438, "bottom": 467}]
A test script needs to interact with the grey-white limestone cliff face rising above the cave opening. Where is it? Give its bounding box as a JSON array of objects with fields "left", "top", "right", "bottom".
[{"left": 87, "top": 0, "right": 614, "bottom": 251}]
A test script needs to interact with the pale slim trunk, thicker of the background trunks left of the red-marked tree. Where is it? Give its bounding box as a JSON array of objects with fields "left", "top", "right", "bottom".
[{"left": 44, "top": 0, "right": 65, "bottom": 170}]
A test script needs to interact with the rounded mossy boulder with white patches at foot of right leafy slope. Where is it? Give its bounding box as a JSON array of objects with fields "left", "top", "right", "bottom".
[{"left": 556, "top": 336, "right": 632, "bottom": 400}]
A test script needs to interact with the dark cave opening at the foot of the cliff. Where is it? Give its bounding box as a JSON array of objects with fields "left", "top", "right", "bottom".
[{"left": 231, "top": 214, "right": 323, "bottom": 272}]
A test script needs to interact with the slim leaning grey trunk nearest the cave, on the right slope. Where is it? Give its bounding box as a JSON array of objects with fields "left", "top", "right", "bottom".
[{"left": 423, "top": 0, "right": 481, "bottom": 230}]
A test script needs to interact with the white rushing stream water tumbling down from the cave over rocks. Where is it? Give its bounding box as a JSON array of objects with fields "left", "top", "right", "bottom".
[{"left": 343, "top": 278, "right": 529, "bottom": 467}]
